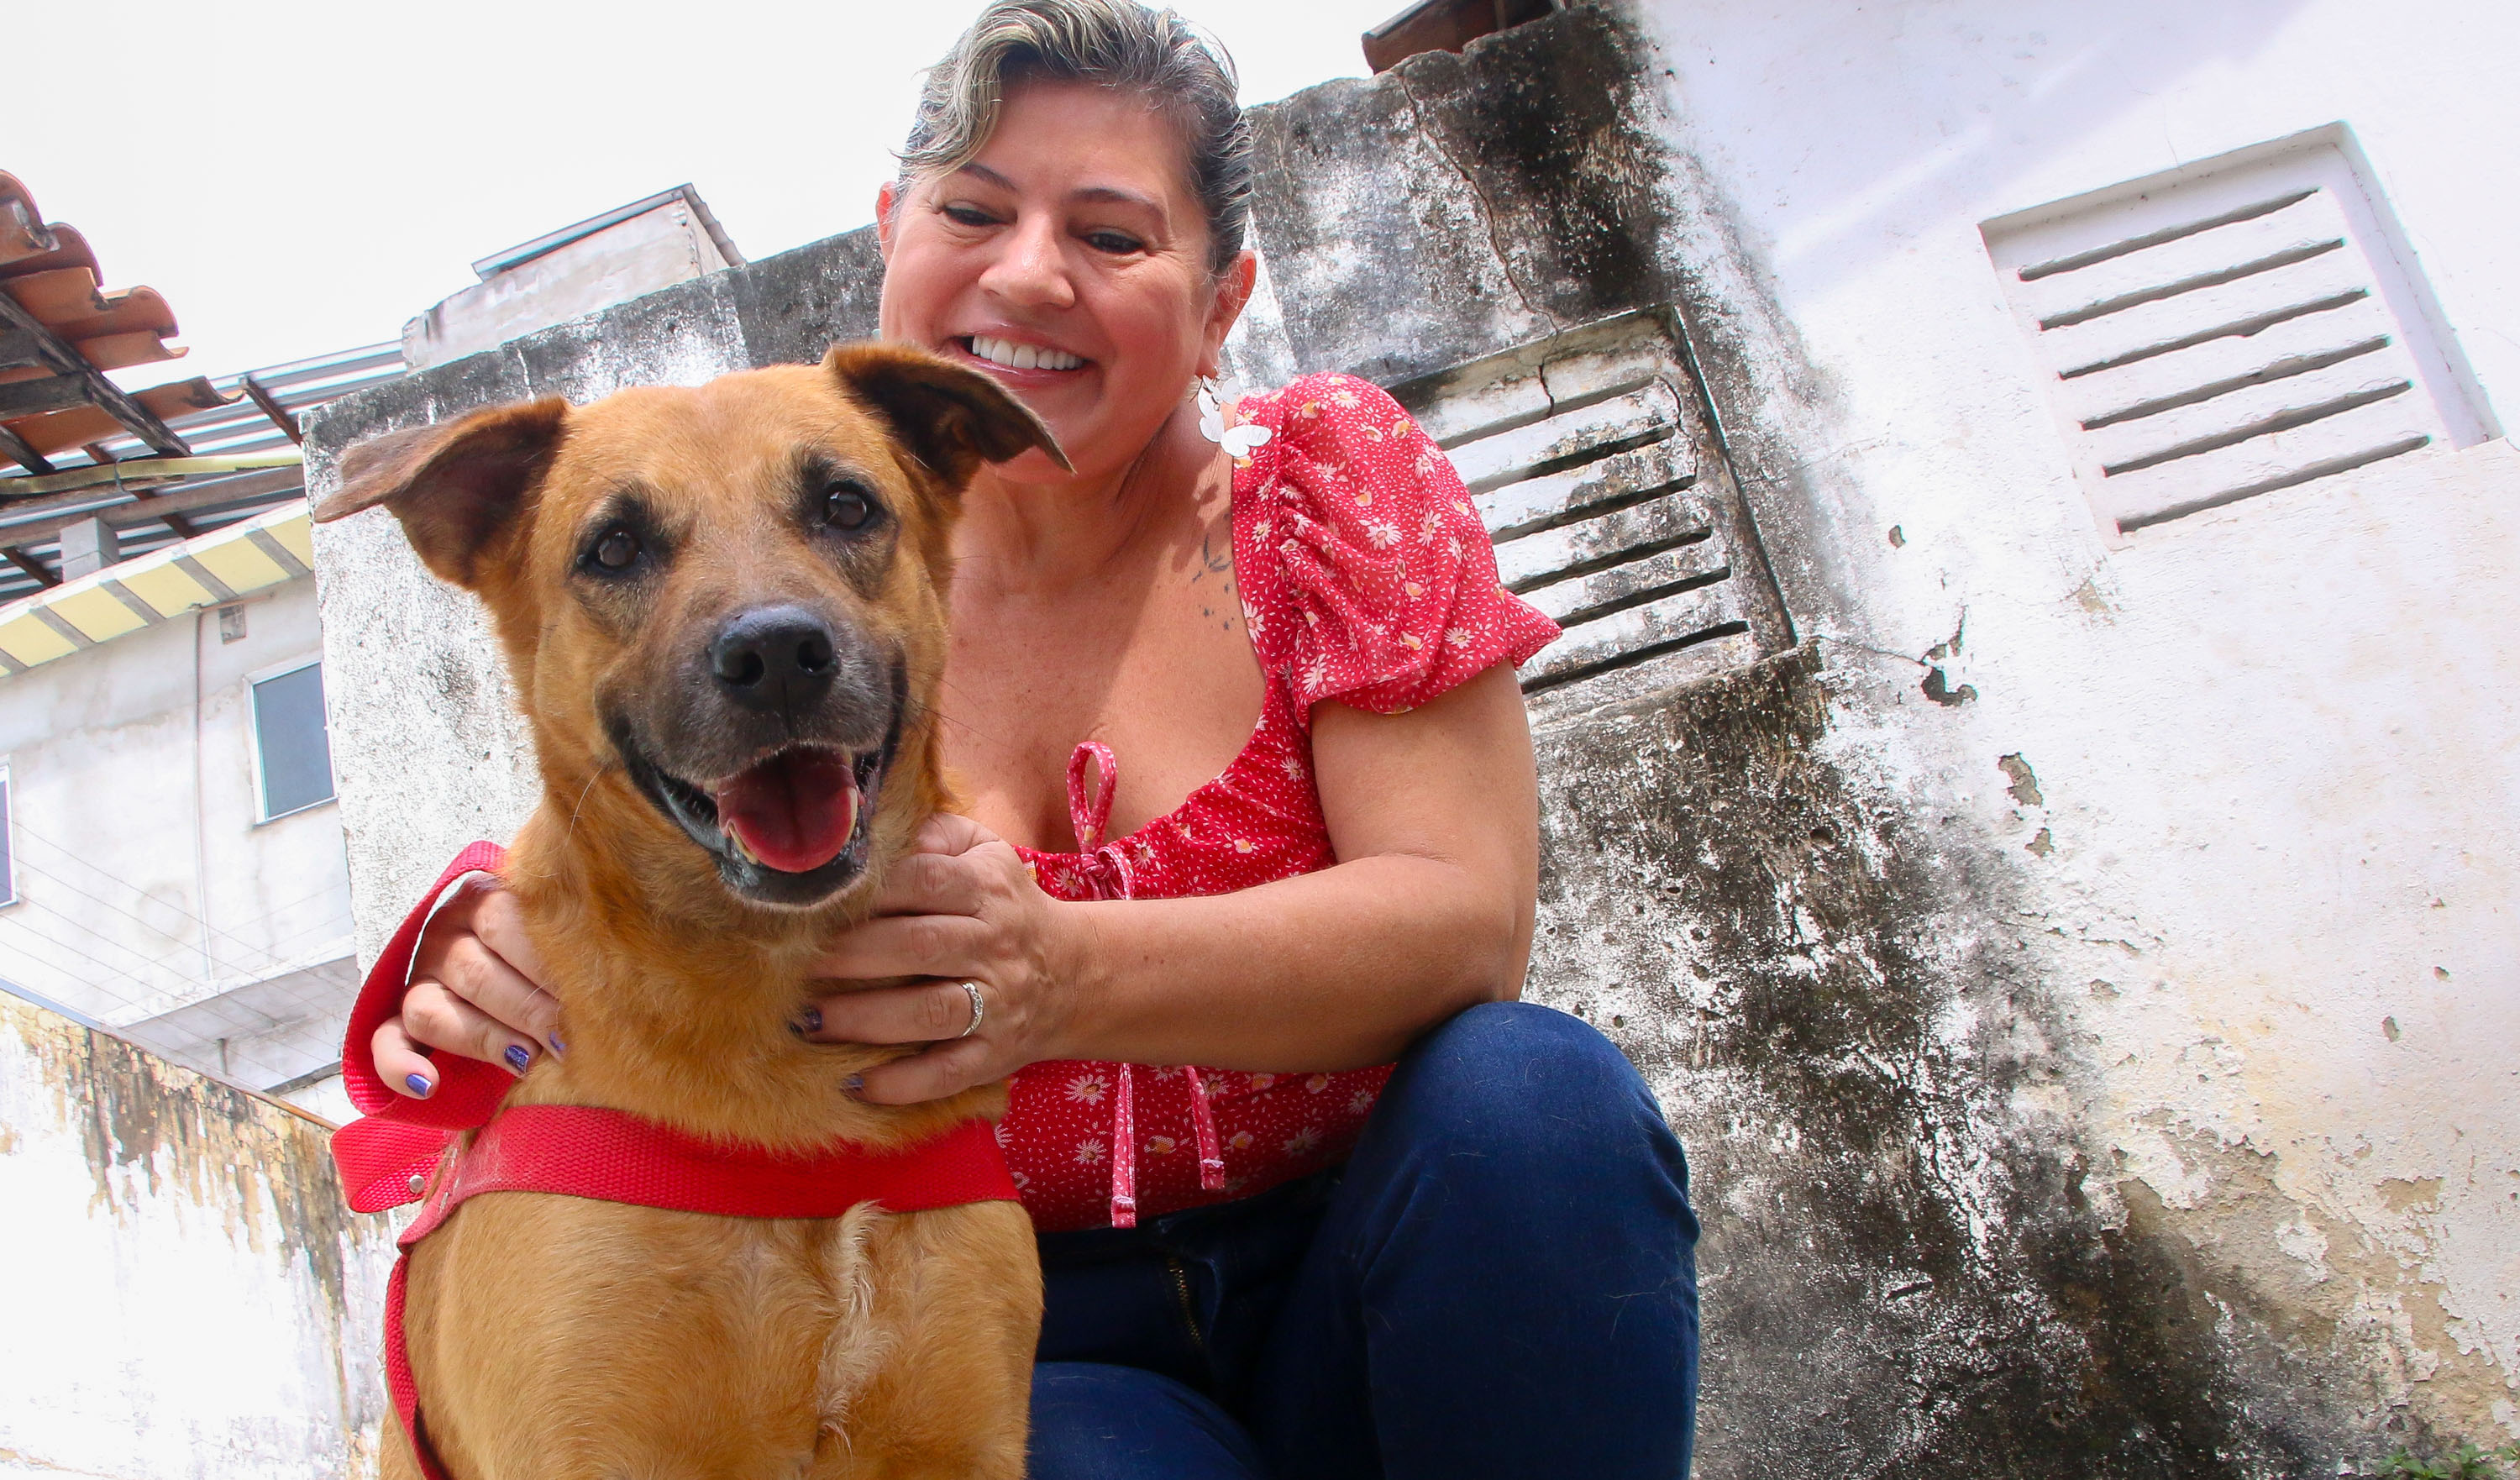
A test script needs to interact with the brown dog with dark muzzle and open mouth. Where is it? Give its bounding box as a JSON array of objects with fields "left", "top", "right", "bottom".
[{"left": 315, "top": 345, "right": 1063, "bottom": 1480}]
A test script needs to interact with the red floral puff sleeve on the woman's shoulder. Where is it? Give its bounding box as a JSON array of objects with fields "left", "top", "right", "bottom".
[{"left": 1235, "top": 375, "right": 1557, "bottom": 721}]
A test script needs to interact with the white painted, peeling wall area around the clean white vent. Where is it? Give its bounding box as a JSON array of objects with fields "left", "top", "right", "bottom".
[{"left": 1635, "top": 0, "right": 2520, "bottom": 1442}]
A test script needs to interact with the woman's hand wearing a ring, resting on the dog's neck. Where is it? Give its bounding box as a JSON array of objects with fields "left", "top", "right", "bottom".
[{"left": 806, "top": 815, "right": 1081, "bottom": 1105}]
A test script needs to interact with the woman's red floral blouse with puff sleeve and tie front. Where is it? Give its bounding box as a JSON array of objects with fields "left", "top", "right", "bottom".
[{"left": 998, "top": 375, "right": 1557, "bottom": 1231}]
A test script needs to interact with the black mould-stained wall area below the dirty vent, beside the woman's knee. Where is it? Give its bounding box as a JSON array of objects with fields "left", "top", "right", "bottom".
[{"left": 1532, "top": 645, "right": 2339, "bottom": 1477}]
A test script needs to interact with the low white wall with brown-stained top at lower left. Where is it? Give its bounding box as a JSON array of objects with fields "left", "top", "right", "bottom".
[{"left": 0, "top": 996, "right": 393, "bottom": 1480}]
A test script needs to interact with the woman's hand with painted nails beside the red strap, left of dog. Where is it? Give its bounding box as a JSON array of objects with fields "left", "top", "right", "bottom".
[{"left": 370, "top": 880, "right": 562, "bottom": 1100}]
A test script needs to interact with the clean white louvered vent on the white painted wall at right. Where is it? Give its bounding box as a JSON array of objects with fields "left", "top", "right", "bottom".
[{"left": 1986, "top": 126, "right": 2490, "bottom": 532}]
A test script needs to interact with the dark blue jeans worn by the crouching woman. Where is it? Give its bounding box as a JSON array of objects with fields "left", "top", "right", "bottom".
[{"left": 1031, "top": 1004, "right": 1698, "bottom": 1480}]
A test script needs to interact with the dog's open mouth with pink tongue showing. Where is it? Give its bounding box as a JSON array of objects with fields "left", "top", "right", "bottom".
[{"left": 615, "top": 728, "right": 900, "bottom": 905}]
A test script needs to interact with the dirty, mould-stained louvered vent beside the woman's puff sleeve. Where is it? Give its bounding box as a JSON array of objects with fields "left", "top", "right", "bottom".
[{"left": 1391, "top": 312, "right": 1792, "bottom": 711}]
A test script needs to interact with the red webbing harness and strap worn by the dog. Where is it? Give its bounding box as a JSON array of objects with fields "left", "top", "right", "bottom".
[{"left": 333, "top": 842, "right": 1016, "bottom": 1480}]
